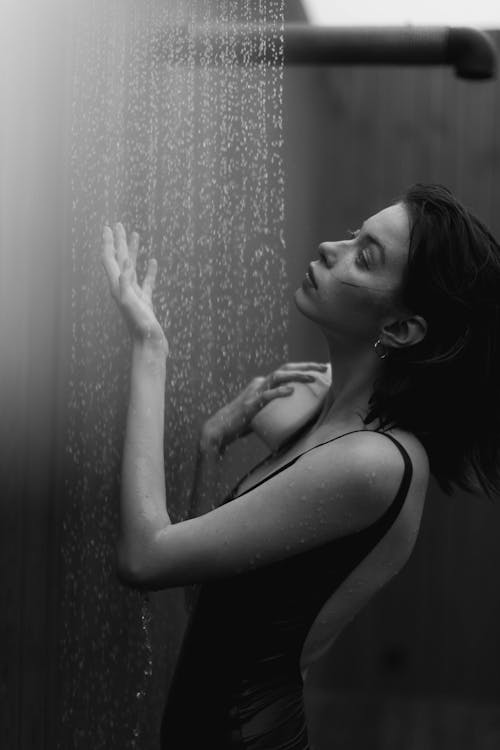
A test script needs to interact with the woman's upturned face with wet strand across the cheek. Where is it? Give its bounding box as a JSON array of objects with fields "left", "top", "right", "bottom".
[{"left": 295, "top": 203, "right": 410, "bottom": 344}]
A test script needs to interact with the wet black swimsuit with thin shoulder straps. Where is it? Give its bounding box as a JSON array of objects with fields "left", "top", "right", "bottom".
[{"left": 161, "top": 425, "right": 412, "bottom": 750}]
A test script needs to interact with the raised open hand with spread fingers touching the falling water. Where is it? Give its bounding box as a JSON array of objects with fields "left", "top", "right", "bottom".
[{"left": 101, "top": 223, "right": 169, "bottom": 355}]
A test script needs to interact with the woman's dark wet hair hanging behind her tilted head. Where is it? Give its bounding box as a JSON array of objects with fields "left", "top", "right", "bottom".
[{"left": 365, "top": 183, "right": 500, "bottom": 499}]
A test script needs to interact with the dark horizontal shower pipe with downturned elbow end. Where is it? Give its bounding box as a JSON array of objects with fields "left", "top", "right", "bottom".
[{"left": 168, "top": 23, "right": 497, "bottom": 80}]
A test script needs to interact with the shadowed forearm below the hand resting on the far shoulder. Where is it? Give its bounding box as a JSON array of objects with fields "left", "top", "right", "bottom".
[{"left": 188, "top": 430, "right": 226, "bottom": 518}]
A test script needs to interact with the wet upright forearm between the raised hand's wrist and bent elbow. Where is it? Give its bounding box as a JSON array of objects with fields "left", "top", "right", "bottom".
[{"left": 118, "top": 343, "right": 171, "bottom": 570}]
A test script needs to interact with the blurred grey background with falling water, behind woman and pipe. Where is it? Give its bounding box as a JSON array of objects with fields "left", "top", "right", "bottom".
[{"left": 0, "top": 0, "right": 500, "bottom": 750}]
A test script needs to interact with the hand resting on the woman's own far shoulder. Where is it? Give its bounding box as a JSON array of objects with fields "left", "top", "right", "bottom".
[{"left": 202, "top": 362, "right": 331, "bottom": 450}]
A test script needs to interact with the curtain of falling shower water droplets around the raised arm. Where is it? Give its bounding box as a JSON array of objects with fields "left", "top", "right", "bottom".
[{"left": 59, "top": 0, "right": 290, "bottom": 750}]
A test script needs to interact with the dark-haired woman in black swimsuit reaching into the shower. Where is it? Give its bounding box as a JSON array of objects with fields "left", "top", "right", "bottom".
[{"left": 102, "top": 184, "right": 500, "bottom": 750}]
